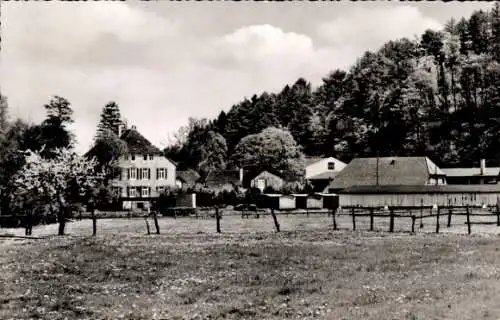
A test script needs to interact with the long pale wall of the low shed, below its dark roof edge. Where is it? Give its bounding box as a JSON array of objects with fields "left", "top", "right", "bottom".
[{"left": 339, "top": 193, "right": 500, "bottom": 207}]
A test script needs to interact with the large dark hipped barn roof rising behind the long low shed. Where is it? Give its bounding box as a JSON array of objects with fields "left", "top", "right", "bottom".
[{"left": 328, "top": 157, "right": 444, "bottom": 189}]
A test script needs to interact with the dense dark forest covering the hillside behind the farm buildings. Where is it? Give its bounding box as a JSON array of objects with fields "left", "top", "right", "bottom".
[{"left": 165, "top": 3, "right": 500, "bottom": 169}]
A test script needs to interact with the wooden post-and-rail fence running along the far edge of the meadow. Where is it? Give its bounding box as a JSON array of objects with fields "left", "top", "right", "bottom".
[{"left": 0, "top": 206, "right": 500, "bottom": 235}]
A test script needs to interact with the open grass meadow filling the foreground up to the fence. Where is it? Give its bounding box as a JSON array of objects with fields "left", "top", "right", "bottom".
[{"left": 0, "top": 216, "right": 500, "bottom": 319}]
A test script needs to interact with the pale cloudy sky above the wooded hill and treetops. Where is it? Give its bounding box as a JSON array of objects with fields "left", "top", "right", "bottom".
[{"left": 0, "top": 1, "right": 492, "bottom": 153}]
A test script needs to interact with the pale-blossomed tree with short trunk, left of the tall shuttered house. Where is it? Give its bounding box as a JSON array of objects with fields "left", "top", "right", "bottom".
[{"left": 13, "top": 148, "right": 102, "bottom": 235}]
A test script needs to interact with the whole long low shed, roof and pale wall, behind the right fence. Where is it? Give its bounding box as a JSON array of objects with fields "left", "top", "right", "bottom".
[{"left": 339, "top": 185, "right": 500, "bottom": 208}]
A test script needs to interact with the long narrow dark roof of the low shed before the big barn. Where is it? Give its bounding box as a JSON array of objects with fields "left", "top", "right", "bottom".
[{"left": 338, "top": 184, "right": 500, "bottom": 194}]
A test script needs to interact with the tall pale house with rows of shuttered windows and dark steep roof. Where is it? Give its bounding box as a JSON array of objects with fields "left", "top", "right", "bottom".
[{"left": 112, "top": 126, "right": 176, "bottom": 210}]
